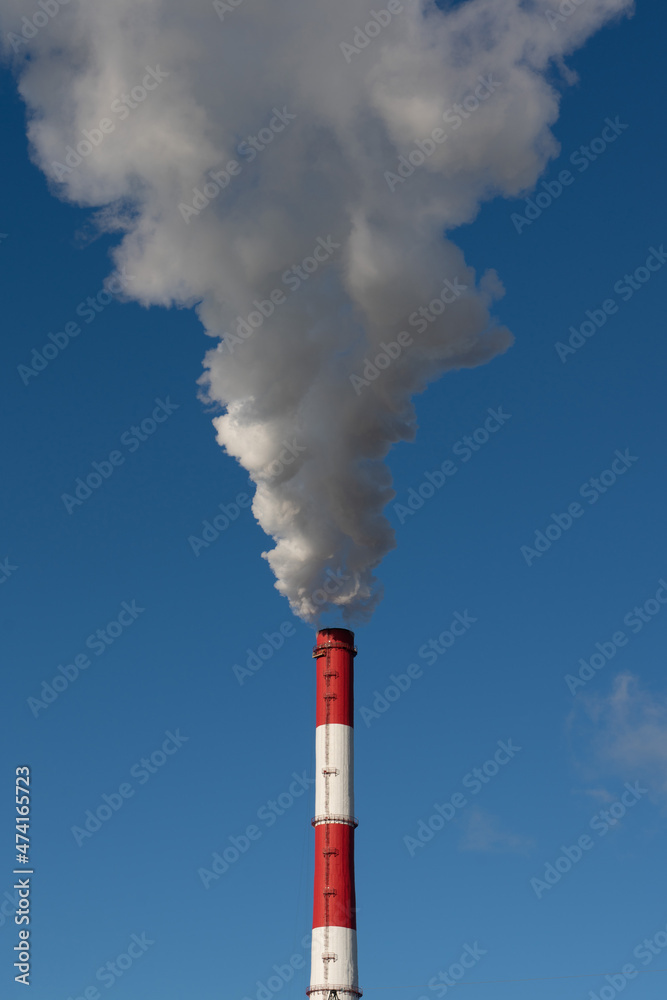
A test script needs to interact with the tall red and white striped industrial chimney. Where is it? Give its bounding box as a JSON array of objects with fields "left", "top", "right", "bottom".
[{"left": 306, "top": 628, "right": 362, "bottom": 1000}]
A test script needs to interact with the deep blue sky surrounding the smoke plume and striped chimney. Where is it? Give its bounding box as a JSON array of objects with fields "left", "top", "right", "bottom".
[{"left": 0, "top": 3, "right": 667, "bottom": 1000}]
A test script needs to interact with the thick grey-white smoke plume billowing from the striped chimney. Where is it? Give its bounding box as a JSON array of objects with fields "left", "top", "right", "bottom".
[{"left": 2, "top": 0, "right": 632, "bottom": 621}]
